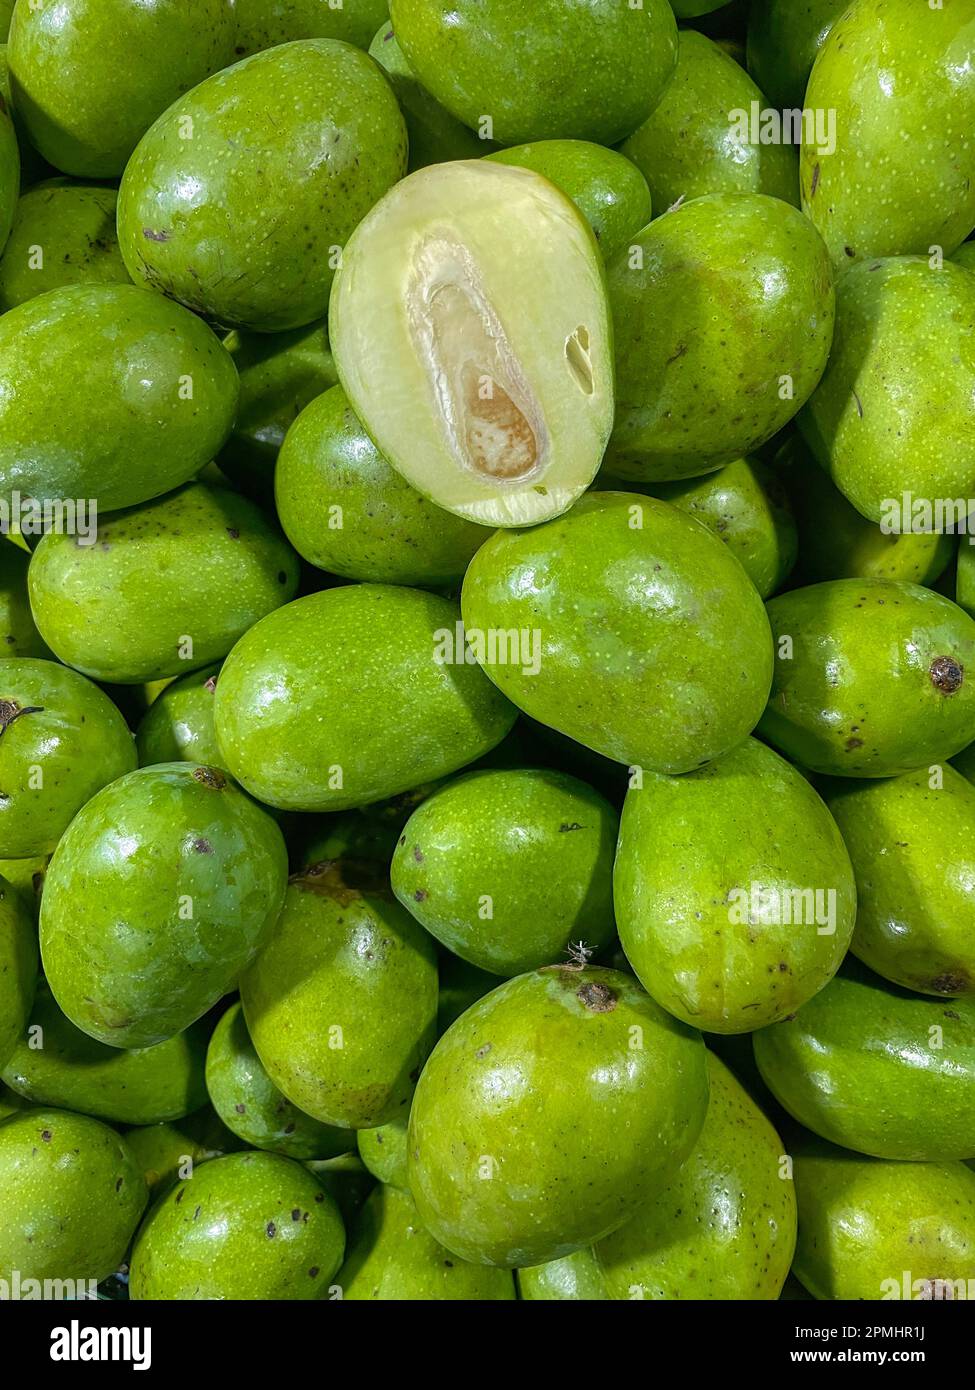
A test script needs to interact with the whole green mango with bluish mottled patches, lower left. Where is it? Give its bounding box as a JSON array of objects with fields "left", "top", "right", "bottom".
[{"left": 40, "top": 763, "right": 288, "bottom": 1048}]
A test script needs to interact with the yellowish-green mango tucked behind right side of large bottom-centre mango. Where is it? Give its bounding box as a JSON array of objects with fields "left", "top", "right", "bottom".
[{"left": 594, "top": 1054, "right": 796, "bottom": 1301}]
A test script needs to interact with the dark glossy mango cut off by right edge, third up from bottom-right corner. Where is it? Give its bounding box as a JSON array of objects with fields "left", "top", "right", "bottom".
[{"left": 754, "top": 959, "right": 975, "bottom": 1162}]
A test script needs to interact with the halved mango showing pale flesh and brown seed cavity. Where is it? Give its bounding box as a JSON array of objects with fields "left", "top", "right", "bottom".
[{"left": 328, "top": 160, "right": 613, "bottom": 527}]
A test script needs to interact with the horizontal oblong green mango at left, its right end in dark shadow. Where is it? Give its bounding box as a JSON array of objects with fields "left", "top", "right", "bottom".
[{"left": 28, "top": 482, "right": 299, "bottom": 685}]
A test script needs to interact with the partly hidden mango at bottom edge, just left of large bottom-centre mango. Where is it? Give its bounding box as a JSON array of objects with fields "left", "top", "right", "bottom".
[{"left": 337, "top": 1184, "right": 516, "bottom": 1302}]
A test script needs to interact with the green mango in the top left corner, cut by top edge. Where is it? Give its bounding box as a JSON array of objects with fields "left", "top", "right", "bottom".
[{"left": 10, "top": 0, "right": 235, "bottom": 178}]
